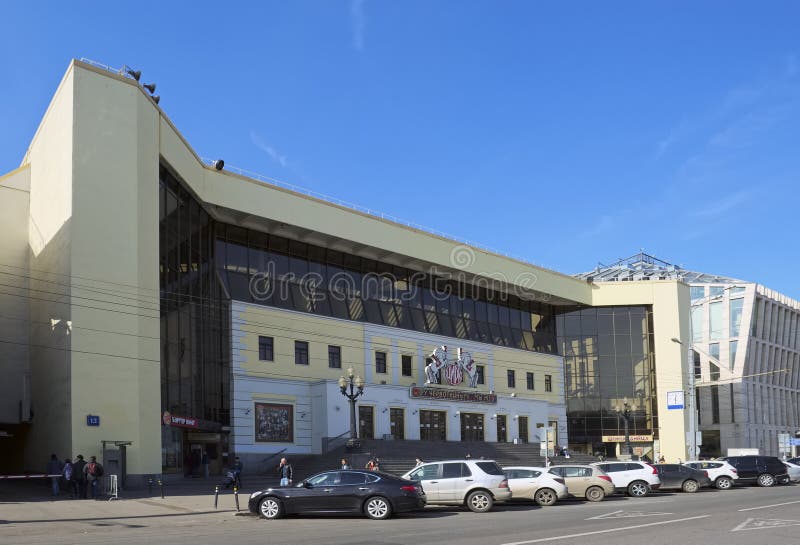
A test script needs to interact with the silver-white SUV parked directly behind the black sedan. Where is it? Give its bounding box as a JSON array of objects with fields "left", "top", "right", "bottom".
[{"left": 403, "top": 460, "right": 511, "bottom": 513}]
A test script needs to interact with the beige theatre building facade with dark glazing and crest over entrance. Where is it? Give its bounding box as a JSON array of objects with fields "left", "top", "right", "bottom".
[{"left": 0, "top": 57, "right": 689, "bottom": 476}]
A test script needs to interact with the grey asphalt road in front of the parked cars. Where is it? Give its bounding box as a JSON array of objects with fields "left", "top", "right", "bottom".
[{"left": 0, "top": 485, "right": 800, "bottom": 545}]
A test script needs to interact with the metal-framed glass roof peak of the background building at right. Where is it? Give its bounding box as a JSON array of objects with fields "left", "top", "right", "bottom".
[{"left": 575, "top": 251, "right": 744, "bottom": 284}]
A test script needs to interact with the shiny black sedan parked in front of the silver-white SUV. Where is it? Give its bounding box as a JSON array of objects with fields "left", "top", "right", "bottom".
[{"left": 248, "top": 470, "right": 426, "bottom": 519}]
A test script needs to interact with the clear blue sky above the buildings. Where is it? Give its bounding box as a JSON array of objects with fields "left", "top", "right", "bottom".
[{"left": 0, "top": 0, "right": 800, "bottom": 299}]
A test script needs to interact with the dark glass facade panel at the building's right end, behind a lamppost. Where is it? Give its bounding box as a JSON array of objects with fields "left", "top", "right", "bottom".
[{"left": 556, "top": 306, "right": 658, "bottom": 452}]
